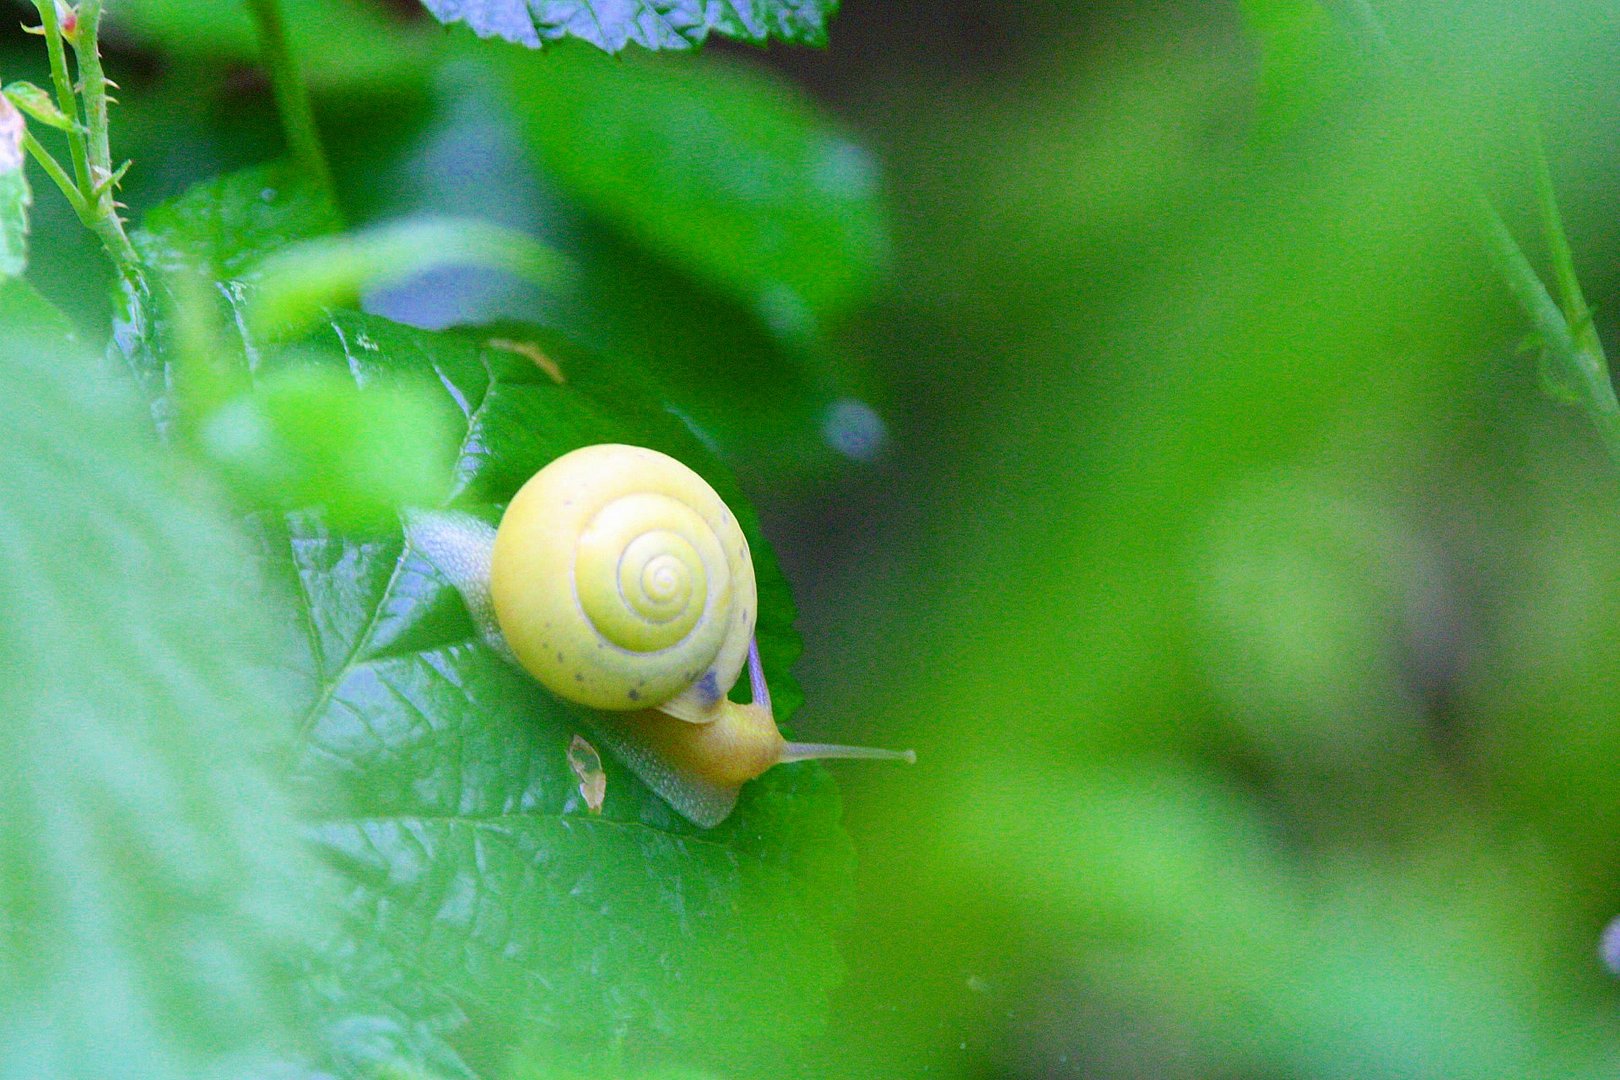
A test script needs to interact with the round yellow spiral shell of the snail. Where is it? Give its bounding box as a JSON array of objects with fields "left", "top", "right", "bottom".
[{"left": 491, "top": 444, "right": 757, "bottom": 711}]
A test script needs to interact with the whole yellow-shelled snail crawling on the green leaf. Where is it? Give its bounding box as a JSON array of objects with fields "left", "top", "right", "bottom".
[{"left": 407, "top": 444, "right": 915, "bottom": 827}]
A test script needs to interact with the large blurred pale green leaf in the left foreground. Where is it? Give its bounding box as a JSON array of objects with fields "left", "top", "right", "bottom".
[{"left": 0, "top": 282, "right": 321, "bottom": 1080}]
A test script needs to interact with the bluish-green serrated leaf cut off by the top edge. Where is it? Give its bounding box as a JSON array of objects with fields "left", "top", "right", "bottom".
[{"left": 423, "top": 0, "right": 838, "bottom": 52}]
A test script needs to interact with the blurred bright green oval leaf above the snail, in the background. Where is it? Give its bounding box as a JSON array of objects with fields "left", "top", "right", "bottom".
[{"left": 491, "top": 49, "right": 886, "bottom": 342}]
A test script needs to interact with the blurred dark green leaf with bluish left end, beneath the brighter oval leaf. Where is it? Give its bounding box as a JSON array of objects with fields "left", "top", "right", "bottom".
[{"left": 368, "top": 68, "right": 885, "bottom": 492}]
